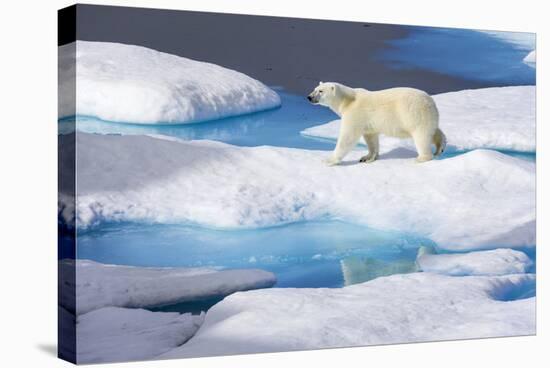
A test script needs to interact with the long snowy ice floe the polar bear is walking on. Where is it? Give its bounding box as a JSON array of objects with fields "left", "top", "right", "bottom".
[{"left": 61, "top": 133, "right": 535, "bottom": 250}]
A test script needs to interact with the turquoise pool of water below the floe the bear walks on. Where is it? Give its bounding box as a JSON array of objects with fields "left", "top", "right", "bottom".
[{"left": 77, "top": 221, "right": 433, "bottom": 287}]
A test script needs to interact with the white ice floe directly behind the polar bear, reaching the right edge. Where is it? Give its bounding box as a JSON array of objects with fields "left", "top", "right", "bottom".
[{"left": 302, "top": 86, "right": 536, "bottom": 152}]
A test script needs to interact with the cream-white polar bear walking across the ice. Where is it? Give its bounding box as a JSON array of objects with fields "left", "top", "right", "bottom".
[{"left": 307, "top": 82, "right": 447, "bottom": 166}]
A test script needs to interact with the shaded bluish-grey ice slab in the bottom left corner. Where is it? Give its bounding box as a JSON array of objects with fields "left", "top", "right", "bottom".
[{"left": 76, "top": 307, "right": 204, "bottom": 364}]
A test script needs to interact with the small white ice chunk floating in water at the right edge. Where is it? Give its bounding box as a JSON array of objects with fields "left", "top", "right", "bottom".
[{"left": 416, "top": 249, "right": 533, "bottom": 276}]
